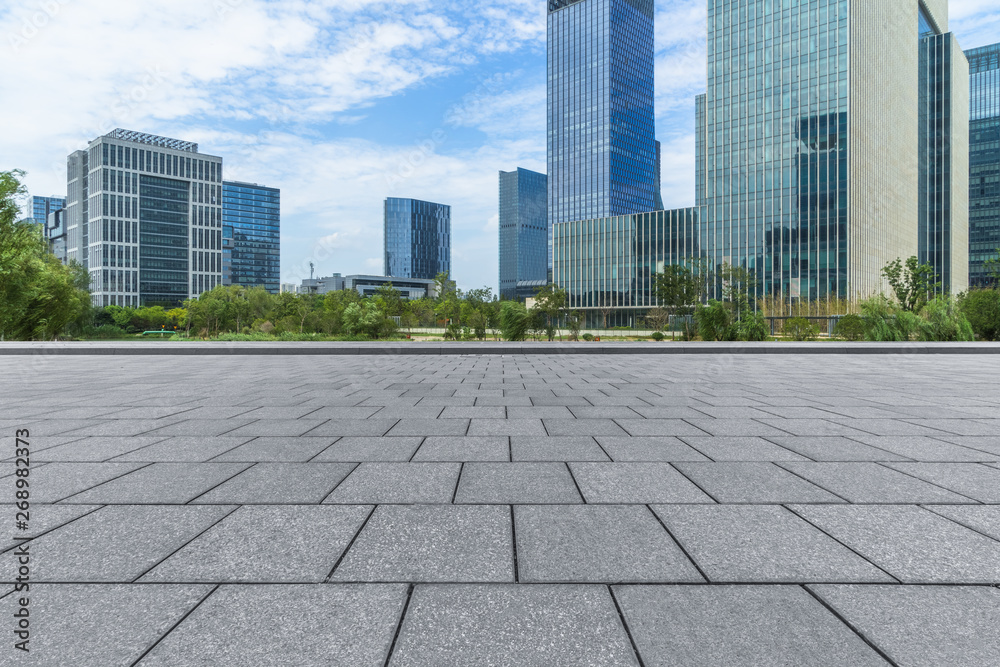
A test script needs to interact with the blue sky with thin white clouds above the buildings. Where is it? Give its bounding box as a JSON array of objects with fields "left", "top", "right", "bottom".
[{"left": 0, "top": 0, "right": 1000, "bottom": 291}]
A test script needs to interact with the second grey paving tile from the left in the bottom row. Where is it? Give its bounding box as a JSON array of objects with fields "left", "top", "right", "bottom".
[{"left": 142, "top": 584, "right": 406, "bottom": 667}]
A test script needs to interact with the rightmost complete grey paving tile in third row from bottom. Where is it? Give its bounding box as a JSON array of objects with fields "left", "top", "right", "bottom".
[{"left": 779, "top": 462, "right": 969, "bottom": 503}]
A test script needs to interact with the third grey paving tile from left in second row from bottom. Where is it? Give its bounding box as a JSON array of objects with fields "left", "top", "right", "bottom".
[{"left": 140, "top": 505, "right": 371, "bottom": 583}]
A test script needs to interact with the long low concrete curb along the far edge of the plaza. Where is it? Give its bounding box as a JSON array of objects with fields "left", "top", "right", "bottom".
[{"left": 0, "top": 341, "right": 1000, "bottom": 356}]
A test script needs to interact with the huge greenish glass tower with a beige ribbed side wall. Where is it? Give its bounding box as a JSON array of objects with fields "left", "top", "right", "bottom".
[{"left": 696, "top": 0, "right": 968, "bottom": 299}]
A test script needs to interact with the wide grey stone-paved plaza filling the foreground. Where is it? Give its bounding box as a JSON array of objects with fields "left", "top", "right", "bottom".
[{"left": 0, "top": 354, "right": 1000, "bottom": 667}]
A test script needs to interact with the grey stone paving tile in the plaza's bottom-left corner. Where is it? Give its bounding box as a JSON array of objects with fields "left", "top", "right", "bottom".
[{"left": 0, "top": 584, "right": 212, "bottom": 667}]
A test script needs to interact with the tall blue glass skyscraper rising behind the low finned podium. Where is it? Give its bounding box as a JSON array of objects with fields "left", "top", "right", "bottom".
[{"left": 548, "top": 0, "right": 659, "bottom": 224}]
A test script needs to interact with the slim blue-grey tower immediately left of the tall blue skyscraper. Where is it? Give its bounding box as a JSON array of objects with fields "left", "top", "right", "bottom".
[{"left": 499, "top": 168, "right": 552, "bottom": 299}]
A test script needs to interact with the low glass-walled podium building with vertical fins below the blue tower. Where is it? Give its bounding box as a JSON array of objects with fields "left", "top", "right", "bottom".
[{"left": 552, "top": 207, "right": 705, "bottom": 325}]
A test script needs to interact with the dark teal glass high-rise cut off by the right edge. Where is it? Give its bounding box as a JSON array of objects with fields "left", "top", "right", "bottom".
[{"left": 965, "top": 44, "right": 1000, "bottom": 287}]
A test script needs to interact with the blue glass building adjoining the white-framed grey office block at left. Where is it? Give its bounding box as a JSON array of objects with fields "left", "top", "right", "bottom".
[{"left": 222, "top": 181, "right": 281, "bottom": 294}]
